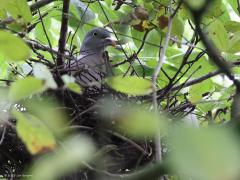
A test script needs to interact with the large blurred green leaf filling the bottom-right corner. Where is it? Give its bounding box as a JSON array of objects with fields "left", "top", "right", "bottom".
[{"left": 170, "top": 127, "right": 240, "bottom": 180}]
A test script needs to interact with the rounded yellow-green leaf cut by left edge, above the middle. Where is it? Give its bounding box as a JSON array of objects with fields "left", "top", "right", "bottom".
[{"left": 0, "top": 30, "right": 30, "bottom": 61}]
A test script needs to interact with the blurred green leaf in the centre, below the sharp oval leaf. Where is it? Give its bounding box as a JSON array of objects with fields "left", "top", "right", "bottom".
[{"left": 100, "top": 99, "right": 168, "bottom": 139}]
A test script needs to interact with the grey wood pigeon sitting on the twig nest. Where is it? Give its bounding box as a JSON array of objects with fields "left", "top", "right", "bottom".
[{"left": 66, "top": 27, "right": 116, "bottom": 87}]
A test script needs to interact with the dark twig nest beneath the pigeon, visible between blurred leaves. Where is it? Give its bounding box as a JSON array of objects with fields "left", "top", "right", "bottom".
[{"left": 0, "top": 68, "right": 194, "bottom": 180}]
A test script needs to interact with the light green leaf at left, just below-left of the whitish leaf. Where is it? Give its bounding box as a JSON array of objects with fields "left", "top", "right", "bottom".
[{"left": 9, "top": 77, "right": 45, "bottom": 101}]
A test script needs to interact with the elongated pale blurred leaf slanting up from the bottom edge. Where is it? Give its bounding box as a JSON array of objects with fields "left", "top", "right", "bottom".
[{"left": 30, "top": 136, "right": 95, "bottom": 180}]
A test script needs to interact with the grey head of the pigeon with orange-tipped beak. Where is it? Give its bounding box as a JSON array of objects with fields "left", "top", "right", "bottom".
[{"left": 80, "top": 27, "right": 116, "bottom": 53}]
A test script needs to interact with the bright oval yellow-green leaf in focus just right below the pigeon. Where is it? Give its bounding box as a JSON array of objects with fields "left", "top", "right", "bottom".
[{"left": 107, "top": 76, "right": 152, "bottom": 96}]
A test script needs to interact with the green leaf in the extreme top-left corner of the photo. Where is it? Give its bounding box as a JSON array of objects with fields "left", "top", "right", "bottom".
[{"left": 0, "top": 0, "right": 32, "bottom": 24}]
